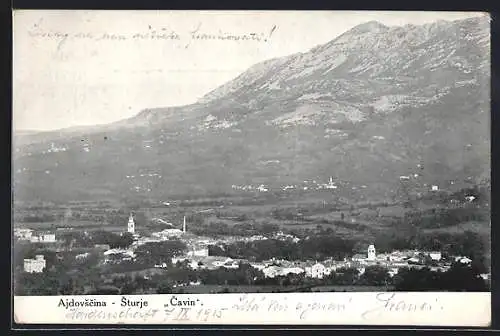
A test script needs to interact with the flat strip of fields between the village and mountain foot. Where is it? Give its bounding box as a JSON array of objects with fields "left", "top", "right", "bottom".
[{"left": 14, "top": 184, "right": 490, "bottom": 247}]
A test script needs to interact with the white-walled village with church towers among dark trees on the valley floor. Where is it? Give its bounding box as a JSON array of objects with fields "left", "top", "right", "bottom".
[{"left": 14, "top": 214, "right": 489, "bottom": 280}]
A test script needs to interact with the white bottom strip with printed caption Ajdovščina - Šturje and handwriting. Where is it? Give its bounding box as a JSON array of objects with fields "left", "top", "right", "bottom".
[{"left": 14, "top": 292, "right": 491, "bottom": 327}]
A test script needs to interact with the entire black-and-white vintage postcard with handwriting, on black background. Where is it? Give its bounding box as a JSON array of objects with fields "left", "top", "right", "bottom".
[{"left": 12, "top": 10, "right": 491, "bottom": 327}]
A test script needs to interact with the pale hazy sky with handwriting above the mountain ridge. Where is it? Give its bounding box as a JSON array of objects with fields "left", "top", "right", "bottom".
[{"left": 13, "top": 10, "right": 488, "bottom": 130}]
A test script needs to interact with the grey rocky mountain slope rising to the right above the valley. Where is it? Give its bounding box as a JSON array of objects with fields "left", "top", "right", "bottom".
[{"left": 13, "top": 18, "right": 490, "bottom": 201}]
